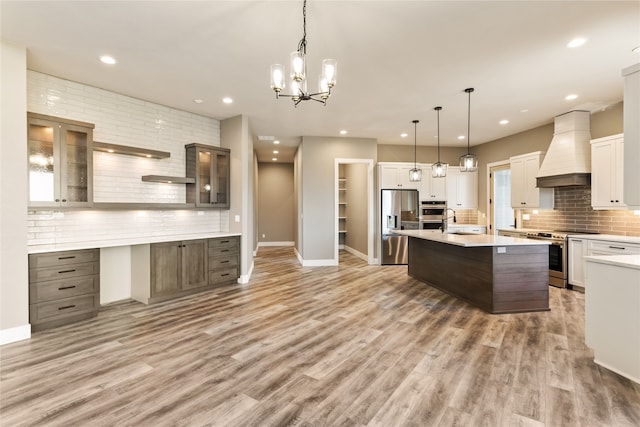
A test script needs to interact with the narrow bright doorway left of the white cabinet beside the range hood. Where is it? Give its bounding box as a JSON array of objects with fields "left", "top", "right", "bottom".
[{"left": 488, "top": 161, "right": 515, "bottom": 234}]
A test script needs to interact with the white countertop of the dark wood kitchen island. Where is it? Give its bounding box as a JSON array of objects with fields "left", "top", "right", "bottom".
[{"left": 394, "top": 230, "right": 551, "bottom": 247}]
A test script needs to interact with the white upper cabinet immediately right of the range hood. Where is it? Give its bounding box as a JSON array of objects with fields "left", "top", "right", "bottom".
[{"left": 591, "top": 134, "right": 624, "bottom": 210}]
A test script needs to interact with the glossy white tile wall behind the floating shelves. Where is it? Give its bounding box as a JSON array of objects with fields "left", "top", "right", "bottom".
[{"left": 27, "top": 70, "right": 229, "bottom": 246}]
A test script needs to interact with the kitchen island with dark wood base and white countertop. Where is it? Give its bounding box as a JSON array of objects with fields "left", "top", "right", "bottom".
[{"left": 397, "top": 230, "right": 549, "bottom": 314}]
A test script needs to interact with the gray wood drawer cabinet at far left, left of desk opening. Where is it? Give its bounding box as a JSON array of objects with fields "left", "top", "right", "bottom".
[{"left": 29, "top": 249, "right": 100, "bottom": 331}]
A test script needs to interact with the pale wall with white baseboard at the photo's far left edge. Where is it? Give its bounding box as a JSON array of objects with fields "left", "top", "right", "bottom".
[{"left": 0, "top": 41, "right": 31, "bottom": 344}]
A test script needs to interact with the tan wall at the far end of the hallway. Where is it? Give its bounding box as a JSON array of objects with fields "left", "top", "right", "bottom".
[{"left": 258, "top": 162, "right": 295, "bottom": 242}]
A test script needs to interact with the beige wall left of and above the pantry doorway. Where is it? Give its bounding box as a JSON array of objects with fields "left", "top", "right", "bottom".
[{"left": 297, "top": 137, "right": 377, "bottom": 265}]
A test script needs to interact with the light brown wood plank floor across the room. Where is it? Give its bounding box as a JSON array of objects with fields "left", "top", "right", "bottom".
[{"left": 0, "top": 247, "right": 640, "bottom": 427}]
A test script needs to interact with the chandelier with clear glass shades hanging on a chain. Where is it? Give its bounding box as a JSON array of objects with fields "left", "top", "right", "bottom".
[{"left": 271, "top": 0, "right": 338, "bottom": 107}]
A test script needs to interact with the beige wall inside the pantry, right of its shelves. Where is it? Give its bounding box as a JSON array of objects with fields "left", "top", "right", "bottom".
[{"left": 344, "top": 163, "right": 369, "bottom": 255}]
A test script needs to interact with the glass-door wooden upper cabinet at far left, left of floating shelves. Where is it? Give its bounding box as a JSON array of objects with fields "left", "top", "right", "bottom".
[{"left": 27, "top": 113, "right": 94, "bottom": 207}]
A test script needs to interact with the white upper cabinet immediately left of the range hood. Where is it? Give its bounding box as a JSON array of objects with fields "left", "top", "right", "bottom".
[{"left": 509, "top": 151, "right": 553, "bottom": 209}]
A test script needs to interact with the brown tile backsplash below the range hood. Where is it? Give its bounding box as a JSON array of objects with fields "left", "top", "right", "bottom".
[{"left": 521, "top": 186, "right": 640, "bottom": 237}]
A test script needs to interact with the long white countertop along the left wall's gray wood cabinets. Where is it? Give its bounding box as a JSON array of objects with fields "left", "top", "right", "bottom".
[{"left": 28, "top": 232, "right": 241, "bottom": 254}]
